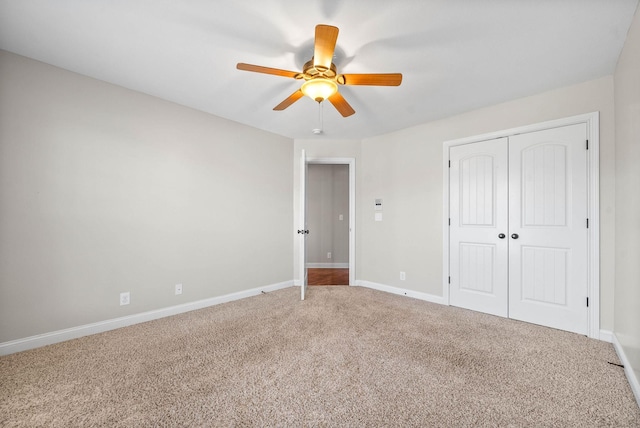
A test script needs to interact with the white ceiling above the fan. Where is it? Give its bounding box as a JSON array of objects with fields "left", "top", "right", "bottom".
[{"left": 0, "top": 0, "right": 638, "bottom": 139}]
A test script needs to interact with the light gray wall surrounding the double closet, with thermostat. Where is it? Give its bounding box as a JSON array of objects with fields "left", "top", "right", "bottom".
[{"left": 358, "top": 77, "right": 615, "bottom": 331}]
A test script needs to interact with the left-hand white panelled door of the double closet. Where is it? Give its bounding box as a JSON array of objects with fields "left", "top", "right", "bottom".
[{"left": 449, "top": 138, "right": 509, "bottom": 317}]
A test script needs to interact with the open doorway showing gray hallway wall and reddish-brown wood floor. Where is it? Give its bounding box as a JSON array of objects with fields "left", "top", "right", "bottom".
[{"left": 306, "top": 163, "right": 351, "bottom": 286}]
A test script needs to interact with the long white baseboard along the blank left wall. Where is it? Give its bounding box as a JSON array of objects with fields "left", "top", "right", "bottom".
[{"left": 0, "top": 281, "right": 293, "bottom": 355}]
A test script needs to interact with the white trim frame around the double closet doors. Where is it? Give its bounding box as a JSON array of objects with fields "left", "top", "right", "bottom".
[{"left": 442, "top": 111, "right": 600, "bottom": 339}]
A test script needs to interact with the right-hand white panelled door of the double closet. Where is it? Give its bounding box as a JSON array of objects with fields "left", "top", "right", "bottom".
[{"left": 509, "top": 124, "right": 588, "bottom": 334}]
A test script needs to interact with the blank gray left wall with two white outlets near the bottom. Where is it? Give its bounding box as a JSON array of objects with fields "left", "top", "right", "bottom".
[{"left": 0, "top": 52, "right": 293, "bottom": 342}]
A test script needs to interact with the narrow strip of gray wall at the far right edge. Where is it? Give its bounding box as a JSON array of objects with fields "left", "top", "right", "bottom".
[{"left": 614, "top": 3, "right": 640, "bottom": 390}]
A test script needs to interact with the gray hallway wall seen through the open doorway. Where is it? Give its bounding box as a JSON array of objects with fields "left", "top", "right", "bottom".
[{"left": 306, "top": 164, "right": 349, "bottom": 264}]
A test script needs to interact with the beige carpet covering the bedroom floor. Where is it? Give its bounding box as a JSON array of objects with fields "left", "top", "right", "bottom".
[{"left": 0, "top": 287, "right": 640, "bottom": 427}]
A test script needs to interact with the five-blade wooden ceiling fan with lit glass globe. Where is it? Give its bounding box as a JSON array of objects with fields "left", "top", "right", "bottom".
[{"left": 236, "top": 24, "right": 402, "bottom": 117}]
